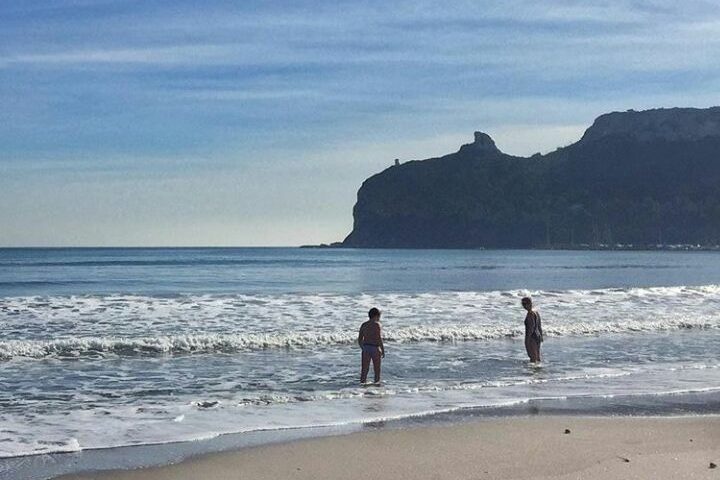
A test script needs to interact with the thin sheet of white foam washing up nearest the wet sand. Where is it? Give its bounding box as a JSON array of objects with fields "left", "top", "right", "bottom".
[{"left": 0, "top": 365, "right": 720, "bottom": 458}]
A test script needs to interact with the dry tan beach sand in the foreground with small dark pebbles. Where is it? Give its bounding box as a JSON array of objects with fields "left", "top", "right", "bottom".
[{"left": 62, "top": 416, "right": 720, "bottom": 480}]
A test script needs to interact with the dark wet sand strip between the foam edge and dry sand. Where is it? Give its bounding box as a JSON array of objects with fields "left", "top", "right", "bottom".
[{"left": 5, "top": 391, "right": 720, "bottom": 480}]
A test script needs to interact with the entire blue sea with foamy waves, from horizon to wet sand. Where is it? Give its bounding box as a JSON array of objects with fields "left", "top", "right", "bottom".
[{"left": 0, "top": 249, "right": 720, "bottom": 458}]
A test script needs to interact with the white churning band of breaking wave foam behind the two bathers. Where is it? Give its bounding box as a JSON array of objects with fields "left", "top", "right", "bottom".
[{"left": 0, "top": 285, "right": 720, "bottom": 359}]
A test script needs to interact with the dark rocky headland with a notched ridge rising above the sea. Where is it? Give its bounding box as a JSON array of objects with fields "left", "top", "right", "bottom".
[{"left": 343, "top": 107, "right": 720, "bottom": 248}]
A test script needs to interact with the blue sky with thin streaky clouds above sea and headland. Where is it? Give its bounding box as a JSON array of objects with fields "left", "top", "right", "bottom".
[{"left": 0, "top": 0, "right": 720, "bottom": 246}]
